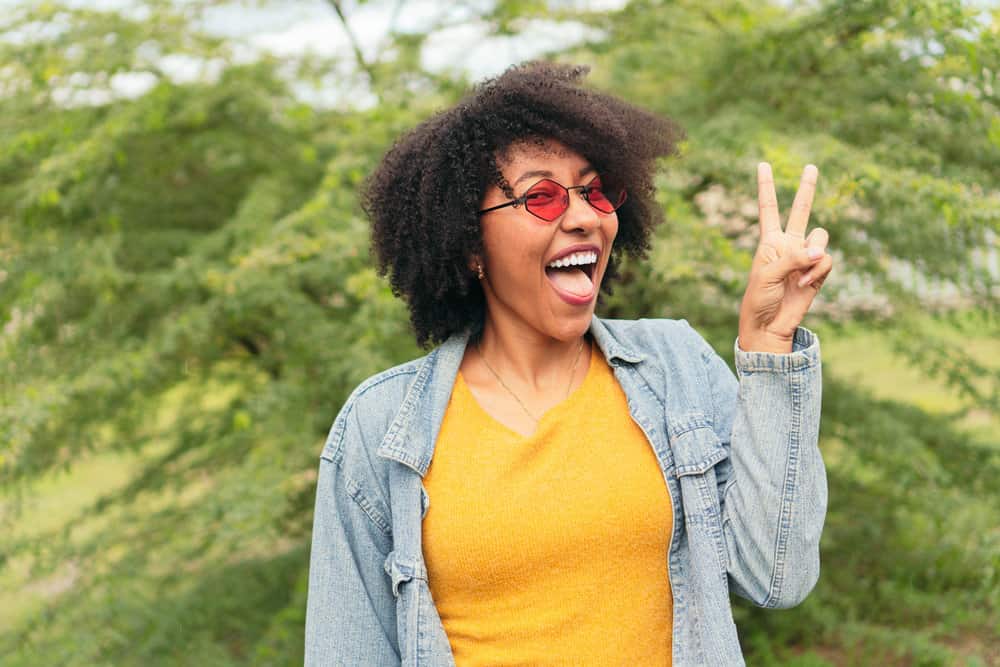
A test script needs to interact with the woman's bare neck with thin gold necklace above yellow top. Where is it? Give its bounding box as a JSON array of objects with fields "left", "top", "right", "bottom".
[{"left": 479, "top": 316, "right": 586, "bottom": 392}]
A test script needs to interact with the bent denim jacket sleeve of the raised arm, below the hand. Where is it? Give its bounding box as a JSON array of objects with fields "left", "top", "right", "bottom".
[{"left": 706, "top": 327, "right": 827, "bottom": 608}]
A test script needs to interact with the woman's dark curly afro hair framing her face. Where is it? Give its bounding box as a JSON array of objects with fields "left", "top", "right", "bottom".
[{"left": 362, "top": 62, "right": 681, "bottom": 347}]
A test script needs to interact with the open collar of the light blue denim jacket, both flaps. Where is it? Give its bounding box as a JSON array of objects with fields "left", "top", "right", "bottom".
[{"left": 376, "top": 316, "right": 645, "bottom": 477}]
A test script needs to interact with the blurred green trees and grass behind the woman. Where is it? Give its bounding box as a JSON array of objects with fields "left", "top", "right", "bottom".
[{"left": 0, "top": 0, "right": 1000, "bottom": 667}]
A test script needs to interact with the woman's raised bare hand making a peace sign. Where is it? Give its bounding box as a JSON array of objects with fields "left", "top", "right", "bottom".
[{"left": 739, "top": 162, "right": 833, "bottom": 353}]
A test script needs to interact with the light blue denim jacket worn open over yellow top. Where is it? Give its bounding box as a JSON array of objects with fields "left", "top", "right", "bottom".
[{"left": 305, "top": 317, "right": 827, "bottom": 667}]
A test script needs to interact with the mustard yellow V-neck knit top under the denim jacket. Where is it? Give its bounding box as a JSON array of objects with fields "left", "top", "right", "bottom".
[{"left": 423, "top": 346, "right": 673, "bottom": 667}]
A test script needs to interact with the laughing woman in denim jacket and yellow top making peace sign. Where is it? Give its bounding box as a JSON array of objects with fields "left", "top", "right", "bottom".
[{"left": 306, "top": 64, "right": 832, "bottom": 665}]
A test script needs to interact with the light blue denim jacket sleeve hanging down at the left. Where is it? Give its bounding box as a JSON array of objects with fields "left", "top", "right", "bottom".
[{"left": 305, "top": 413, "right": 400, "bottom": 667}]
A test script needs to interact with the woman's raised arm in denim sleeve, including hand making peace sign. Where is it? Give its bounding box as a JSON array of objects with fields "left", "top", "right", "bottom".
[{"left": 706, "top": 162, "right": 833, "bottom": 607}]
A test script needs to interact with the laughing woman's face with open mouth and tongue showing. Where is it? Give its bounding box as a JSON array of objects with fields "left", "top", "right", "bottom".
[{"left": 480, "top": 140, "right": 618, "bottom": 341}]
